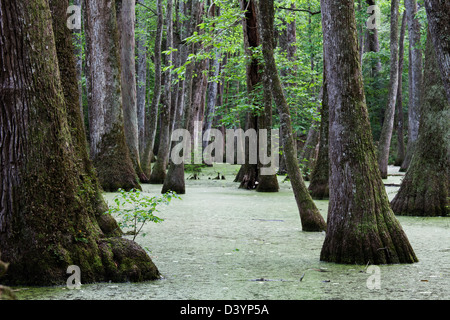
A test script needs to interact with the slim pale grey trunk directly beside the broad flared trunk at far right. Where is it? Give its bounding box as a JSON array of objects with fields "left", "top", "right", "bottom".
[{"left": 400, "top": 0, "right": 423, "bottom": 171}]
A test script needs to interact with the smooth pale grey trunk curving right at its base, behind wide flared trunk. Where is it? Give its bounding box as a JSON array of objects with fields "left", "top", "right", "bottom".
[{"left": 116, "top": 0, "right": 147, "bottom": 181}]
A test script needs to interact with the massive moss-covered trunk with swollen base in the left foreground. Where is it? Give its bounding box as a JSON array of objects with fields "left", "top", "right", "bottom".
[{"left": 0, "top": 0, "right": 159, "bottom": 286}]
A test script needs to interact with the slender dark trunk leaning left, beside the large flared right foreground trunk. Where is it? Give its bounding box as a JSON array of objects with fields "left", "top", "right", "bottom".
[{"left": 259, "top": 1, "right": 326, "bottom": 231}]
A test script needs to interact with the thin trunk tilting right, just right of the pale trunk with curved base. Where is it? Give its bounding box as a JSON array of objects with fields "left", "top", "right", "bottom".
[{"left": 150, "top": 0, "right": 173, "bottom": 184}]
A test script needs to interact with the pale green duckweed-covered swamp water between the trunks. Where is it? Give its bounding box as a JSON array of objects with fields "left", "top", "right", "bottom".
[{"left": 14, "top": 165, "right": 450, "bottom": 300}]
